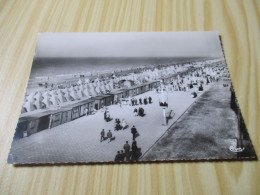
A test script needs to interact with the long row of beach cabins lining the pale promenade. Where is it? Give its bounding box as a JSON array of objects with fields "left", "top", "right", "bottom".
[{"left": 14, "top": 81, "right": 160, "bottom": 142}]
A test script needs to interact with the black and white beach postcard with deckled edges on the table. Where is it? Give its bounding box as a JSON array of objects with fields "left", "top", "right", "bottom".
[{"left": 7, "top": 31, "right": 256, "bottom": 164}]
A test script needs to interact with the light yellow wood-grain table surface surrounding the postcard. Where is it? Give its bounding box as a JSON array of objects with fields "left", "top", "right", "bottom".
[{"left": 0, "top": 0, "right": 260, "bottom": 195}]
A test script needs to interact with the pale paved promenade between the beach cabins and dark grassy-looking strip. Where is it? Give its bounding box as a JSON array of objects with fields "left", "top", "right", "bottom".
[{"left": 9, "top": 85, "right": 211, "bottom": 163}]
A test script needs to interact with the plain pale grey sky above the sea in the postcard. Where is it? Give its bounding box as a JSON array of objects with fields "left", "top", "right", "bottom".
[{"left": 35, "top": 31, "right": 223, "bottom": 58}]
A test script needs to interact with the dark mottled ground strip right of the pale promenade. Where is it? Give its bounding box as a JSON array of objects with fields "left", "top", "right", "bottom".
[{"left": 141, "top": 82, "right": 241, "bottom": 160}]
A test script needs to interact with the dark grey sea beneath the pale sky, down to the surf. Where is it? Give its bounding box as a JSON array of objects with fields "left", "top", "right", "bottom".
[{"left": 30, "top": 57, "right": 214, "bottom": 79}]
